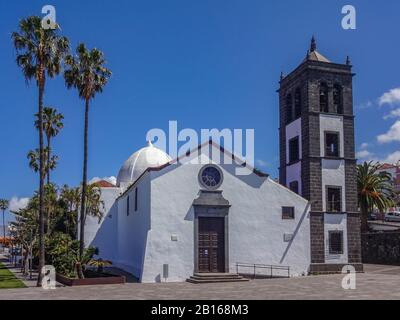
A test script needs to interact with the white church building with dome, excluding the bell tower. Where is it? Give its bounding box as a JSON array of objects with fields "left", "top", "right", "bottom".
[{"left": 85, "top": 142, "right": 310, "bottom": 282}]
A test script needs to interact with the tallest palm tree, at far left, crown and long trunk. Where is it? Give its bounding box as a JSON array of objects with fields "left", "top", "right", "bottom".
[{"left": 11, "top": 16, "right": 69, "bottom": 286}]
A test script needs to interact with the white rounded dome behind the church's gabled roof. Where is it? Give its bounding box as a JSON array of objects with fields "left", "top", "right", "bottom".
[{"left": 117, "top": 142, "right": 172, "bottom": 188}]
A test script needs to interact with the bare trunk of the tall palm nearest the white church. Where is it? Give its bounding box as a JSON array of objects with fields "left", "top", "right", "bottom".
[{"left": 79, "top": 99, "right": 89, "bottom": 258}]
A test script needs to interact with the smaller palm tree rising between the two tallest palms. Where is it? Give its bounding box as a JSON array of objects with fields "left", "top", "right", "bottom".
[{"left": 35, "top": 107, "right": 64, "bottom": 184}]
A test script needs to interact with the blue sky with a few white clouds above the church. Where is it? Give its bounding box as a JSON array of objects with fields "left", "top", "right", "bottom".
[{"left": 0, "top": 0, "right": 400, "bottom": 221}]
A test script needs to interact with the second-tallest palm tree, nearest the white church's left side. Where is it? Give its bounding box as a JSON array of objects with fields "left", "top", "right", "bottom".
[{"left": 64, "top": 43, "right": 111, "bottom": 256}]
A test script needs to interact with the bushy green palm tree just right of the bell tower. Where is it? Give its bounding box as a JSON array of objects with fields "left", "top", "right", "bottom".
[{"left": 357, "top": 161, "right": 395, "bottom": 232}]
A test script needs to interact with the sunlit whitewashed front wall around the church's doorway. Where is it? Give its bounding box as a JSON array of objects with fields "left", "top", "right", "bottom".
[{"left": 142, "top": 144, "right": 310, "bottom": 282}]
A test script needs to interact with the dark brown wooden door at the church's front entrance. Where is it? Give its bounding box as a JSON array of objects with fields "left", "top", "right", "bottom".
[{"left": 198, "top": 218, "right": 225, "bottom": 273}]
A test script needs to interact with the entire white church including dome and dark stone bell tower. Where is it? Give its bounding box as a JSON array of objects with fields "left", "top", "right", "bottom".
[{"left": 85, "top": 38, "right": 362, "bottom": 282}]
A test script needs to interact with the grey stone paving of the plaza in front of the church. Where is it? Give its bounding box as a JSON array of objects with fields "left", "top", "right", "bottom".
[{"left": 0, "top": 265, "right": 400, "bottom": 300}]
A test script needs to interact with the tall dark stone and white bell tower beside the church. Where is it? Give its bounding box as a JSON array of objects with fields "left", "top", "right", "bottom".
[{"left": 278, "top": 37, "right": 362, "bottom": 273}]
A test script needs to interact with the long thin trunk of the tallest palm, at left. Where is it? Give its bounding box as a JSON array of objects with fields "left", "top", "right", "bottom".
[{"left": 36, "top": 76, "right": 45, "bottom": 287}]
